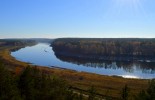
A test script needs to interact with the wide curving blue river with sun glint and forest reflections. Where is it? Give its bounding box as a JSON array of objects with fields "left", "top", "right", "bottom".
[{"left": 11, "top": 43, "right": 155, "bottom": 79}]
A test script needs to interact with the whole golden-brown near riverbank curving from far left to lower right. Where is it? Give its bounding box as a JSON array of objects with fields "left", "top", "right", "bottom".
[{"left": 0, "top": 47, "right": 148, "bottom": 98}]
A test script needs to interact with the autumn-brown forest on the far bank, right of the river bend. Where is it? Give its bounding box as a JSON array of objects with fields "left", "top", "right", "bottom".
[{"left": 51, "top": 38, "right": 155, "bottom": 61}]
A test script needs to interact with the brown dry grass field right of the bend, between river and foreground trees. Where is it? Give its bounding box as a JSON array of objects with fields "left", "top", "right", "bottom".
[{"left": 44, "top": 68, "right": 148, "bottom": 97}]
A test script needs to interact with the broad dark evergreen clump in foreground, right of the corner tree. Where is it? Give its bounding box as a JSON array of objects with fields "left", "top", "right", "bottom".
[{"left": 18, "top": 67, "right": 75, "bottom": 100}]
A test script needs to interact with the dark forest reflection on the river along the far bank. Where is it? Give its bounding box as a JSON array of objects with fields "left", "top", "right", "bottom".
[{"left": 55, "top": 53, "right": 155, "bottom": 74}]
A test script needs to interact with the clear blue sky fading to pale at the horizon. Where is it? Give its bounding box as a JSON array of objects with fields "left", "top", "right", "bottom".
[{"left": 0, "top": 0, "right": 155, "bottom": 38}]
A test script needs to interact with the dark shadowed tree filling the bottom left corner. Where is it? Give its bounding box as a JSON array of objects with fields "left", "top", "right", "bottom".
[{"left": 0, "top": 64, "right": 21, "bottom": 100}]
